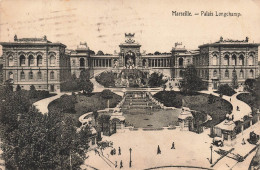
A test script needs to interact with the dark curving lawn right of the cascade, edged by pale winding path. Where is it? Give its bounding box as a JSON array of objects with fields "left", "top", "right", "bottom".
[{"left": 154, "top": 91, "right": 232, "bottom": 127}]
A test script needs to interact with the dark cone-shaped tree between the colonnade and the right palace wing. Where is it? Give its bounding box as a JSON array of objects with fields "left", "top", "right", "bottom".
[{"left": 180, "top": 65, "right": 205, "bottom": 94}]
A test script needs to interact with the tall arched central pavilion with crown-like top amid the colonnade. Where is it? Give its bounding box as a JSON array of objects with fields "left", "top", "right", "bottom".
[{"left": 119, "top": 33, "right": 142, "bottom": 69}]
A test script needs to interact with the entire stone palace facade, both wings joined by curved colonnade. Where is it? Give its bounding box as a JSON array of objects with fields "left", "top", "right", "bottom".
[{"left": 0, "top": 33, "right": 259, "bottom": 91}]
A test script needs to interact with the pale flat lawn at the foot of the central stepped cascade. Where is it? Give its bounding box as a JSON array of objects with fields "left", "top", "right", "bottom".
[{"left": 124, "top": 109, "right": 181, "bottom": 128}]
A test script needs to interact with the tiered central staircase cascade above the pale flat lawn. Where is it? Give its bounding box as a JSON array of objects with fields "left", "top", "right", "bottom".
[{"left": 121, "top": 91, "right": 161, "bottom": 114}]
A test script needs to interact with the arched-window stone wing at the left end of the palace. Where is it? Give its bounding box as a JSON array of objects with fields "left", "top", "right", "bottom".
[{"left": 0, "top": 36, "right": 71, "bottom": 92}]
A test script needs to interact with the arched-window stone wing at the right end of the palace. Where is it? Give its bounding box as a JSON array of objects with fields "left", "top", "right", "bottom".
[{"left": 196, "top": 37, "right": 259, "bottom": 89}]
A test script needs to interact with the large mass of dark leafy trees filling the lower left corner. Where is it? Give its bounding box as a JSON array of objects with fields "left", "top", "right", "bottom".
[{"left": 0, "top": 87, "right": 91, "bottom": 170}]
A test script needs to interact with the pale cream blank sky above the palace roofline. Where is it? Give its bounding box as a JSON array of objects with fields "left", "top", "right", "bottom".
[{"left": 0, "top": 0, "right": 260, "bottom": 59}]
